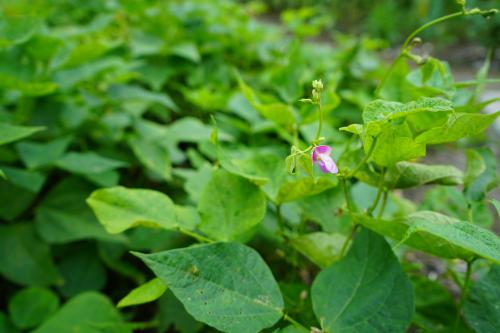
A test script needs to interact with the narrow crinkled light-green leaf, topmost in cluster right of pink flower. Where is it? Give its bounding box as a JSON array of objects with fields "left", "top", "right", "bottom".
[{"left": 363, "top": 98, "right": 453, "bottom": 124}]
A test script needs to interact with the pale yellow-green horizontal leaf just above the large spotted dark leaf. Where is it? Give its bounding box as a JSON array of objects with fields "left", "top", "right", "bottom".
[{"left": 87, "top": 186, "right": 198, "bottom": 234}]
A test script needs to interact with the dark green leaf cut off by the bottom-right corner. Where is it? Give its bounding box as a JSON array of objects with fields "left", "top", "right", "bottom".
[{"left": 464, "top": 265, "right": 500, "bottom": 333}]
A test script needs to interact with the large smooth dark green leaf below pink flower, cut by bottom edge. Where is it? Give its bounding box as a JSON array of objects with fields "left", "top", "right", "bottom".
[{"left": 311, "top": 229, "right": 413, "bottom": 333}]
